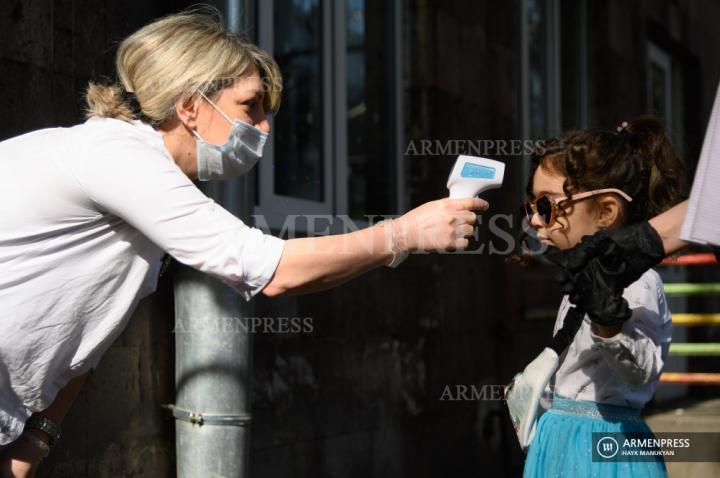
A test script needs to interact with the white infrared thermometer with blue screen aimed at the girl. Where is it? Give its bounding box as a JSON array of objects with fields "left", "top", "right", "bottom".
[{"left": 448, "top": 155, "right": 505, "bottom": 199}]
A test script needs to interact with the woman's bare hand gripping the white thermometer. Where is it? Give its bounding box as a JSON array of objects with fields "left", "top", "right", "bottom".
[{"left": 393, "top": 198, "right": 488, "bottom": 252}]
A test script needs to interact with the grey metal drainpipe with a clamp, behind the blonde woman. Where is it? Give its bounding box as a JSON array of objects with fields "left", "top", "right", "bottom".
[{"left": 168, "top": 0, "right": 254, "bottom": 478}]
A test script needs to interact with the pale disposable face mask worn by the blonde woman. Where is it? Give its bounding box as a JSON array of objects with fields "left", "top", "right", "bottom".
[{"left": 193, "top": 90, "right": 268, "bottom": 181}]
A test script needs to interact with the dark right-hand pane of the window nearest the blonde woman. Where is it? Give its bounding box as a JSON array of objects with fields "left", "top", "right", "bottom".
[{"left": 338, "top": 0, "right": 401, "bottom": 218}]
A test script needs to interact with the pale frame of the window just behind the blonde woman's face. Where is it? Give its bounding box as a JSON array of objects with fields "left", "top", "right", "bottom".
[{"left": 254, "top": 0, "right": 406, "bottom": 233}]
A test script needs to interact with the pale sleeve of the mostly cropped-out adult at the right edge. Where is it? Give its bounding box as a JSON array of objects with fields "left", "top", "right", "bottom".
[{"left": 680, "top": 80, "right": 720, "bottom": 246}]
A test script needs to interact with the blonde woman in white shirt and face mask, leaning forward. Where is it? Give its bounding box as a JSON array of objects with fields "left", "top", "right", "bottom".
[{"left": 0, "top": 6, "right": 487, "bottom": 476}]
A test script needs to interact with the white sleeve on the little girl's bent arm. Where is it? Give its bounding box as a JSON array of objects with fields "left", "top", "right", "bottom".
[{"left": 590, "top": 271, "right": 672, "bottom": 387}]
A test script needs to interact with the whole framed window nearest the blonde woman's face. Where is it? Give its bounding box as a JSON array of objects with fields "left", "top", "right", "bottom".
[{"left": 255, "top": 0, "right": 402, "bottom": 232}]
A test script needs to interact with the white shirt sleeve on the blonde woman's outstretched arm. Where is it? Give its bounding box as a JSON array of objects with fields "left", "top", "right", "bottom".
[{"left": 76, "top": 138, "right": 284, "bottom": 300}]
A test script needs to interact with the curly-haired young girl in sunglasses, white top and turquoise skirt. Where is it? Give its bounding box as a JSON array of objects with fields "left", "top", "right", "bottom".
[{"left": 524, "top": 117, "right": 682, "bottom": 478}]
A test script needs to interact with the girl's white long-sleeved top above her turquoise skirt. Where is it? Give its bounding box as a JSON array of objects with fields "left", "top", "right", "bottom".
[{"left": 550, "top": 269, "right": 672, "bottom": 408}]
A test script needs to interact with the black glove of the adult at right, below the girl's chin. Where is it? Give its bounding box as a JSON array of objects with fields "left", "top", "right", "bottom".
[{"left": 545, "top": 222, "right": 665, "bottom": 325}]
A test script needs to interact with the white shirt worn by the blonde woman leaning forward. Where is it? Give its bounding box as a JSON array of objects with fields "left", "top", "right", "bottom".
[{"left": 0, "top": 119, "right": 284, "bottom": 444}]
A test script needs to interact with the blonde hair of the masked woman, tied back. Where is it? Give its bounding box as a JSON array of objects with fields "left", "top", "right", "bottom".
[{"left": 85, "top": 6, "right": 282, "bottom": 125}]
